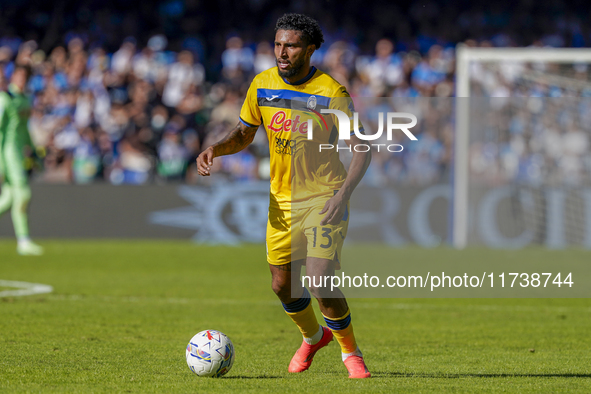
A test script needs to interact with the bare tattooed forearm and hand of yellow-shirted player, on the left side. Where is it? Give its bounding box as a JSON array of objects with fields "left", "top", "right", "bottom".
[{"left": 197, "top": 122, "right": 258, "bottom": 176}]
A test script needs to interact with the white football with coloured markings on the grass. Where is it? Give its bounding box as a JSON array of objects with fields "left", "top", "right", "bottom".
[{"left": 186, "top": 330, "right": 234, "bottom": 378}]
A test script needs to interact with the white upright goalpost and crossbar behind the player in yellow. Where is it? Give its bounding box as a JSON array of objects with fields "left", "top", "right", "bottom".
[{"left": 452, "top": 44, "right": 591, "bottom": 249}]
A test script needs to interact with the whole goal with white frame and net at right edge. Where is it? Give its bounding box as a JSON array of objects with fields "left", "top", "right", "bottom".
[{"left": 453, "top": 47, "right": 591, "bottom": 248}]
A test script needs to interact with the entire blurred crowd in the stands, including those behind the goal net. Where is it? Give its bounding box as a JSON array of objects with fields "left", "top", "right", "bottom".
[{"left": 0, "top": 0, "right": 591, "bottom": 184}]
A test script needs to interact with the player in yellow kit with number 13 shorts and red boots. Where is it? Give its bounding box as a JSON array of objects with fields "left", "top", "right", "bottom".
[{"left": 197, "top": 14, "right": 371, "bottom": 378}]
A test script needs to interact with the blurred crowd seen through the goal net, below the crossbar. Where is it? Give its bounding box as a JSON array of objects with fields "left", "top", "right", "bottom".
[{"left": 469, "top": 62, "right": 591, "bottom": 186}]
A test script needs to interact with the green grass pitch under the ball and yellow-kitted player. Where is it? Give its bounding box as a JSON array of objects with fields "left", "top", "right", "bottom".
[{"left": 0, "top": 240, "right": 591, "bottom": 393}]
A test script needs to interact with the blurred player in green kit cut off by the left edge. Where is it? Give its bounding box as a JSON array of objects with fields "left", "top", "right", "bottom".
[{"left": 0, "top": 65, "right": 43, "bottom": 256}]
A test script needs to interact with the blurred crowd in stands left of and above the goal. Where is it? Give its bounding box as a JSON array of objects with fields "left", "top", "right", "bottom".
[{"left": 0, "top": 0, "right": 591, "bottom": 184}]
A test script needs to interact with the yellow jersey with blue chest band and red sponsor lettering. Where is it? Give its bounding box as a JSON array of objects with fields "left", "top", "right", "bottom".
[{"left": 240, "top": 67, "right": 363, "bottom": 210}]
